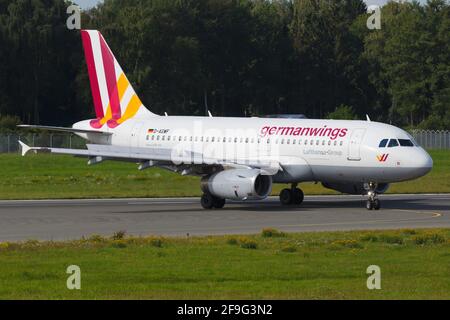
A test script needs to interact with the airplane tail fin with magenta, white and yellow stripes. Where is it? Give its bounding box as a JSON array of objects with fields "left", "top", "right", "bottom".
[{"left": 81, "top": 30, "right": 157, "bottom": 129}]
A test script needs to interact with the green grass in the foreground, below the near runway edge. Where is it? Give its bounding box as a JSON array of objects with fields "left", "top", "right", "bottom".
[{"left": 0, "top": 229, "right": 450, "bottom": 299}]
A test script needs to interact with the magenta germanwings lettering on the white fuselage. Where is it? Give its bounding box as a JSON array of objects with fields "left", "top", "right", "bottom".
[{"left": 260, "top": 126, "right": 348, "bottom": 140}]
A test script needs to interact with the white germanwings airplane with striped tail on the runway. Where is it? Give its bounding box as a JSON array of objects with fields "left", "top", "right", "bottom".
[{"left": 19, "top": 30, "right": 433, "bottom": 210}]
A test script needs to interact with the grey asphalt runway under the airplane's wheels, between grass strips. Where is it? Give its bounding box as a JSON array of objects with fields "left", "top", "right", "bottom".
[{"left": 0, "top": 195, "right": 450, "bottom": 241}]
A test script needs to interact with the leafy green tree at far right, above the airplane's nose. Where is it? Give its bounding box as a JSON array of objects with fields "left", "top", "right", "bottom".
[{"left": 364, "top": 0, "right": 450, "bottom": 127}]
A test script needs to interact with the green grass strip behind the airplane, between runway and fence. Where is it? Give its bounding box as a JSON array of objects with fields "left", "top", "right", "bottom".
[{"left": 0, "top": 150, "right": 450, "bottom": 199}]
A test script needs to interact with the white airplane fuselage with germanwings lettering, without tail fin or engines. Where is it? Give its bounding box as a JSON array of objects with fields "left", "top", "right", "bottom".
[{"left": 74, "top": 117, "right": 433, "bottom": 183}]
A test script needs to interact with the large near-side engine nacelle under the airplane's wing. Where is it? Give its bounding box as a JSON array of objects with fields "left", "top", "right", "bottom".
[{"left": 201, "top": 169, "right": 272, "bottom": 200}]
